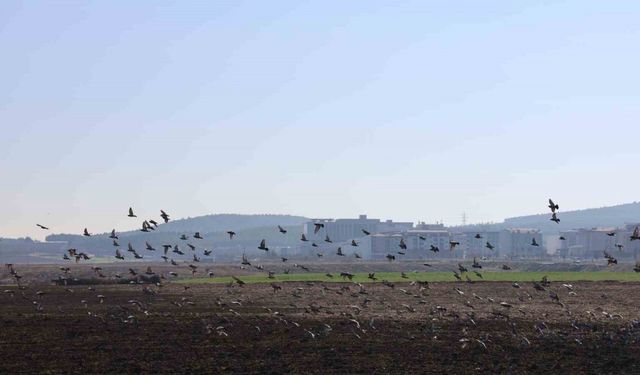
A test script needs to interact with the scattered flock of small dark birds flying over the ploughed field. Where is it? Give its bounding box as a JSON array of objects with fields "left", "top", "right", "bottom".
[{"left": 5, "top": 199, "right": 640, "bottom": 349}]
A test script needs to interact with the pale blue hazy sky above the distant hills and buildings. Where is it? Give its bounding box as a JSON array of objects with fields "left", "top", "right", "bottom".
[{"left": 0, "top": 0, "right": 640, "bottom": 238}]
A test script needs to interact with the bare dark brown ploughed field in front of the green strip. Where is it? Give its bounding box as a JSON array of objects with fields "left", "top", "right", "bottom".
[{"left": 0, "top": 268, "right": 640, "bottom": 374}]
